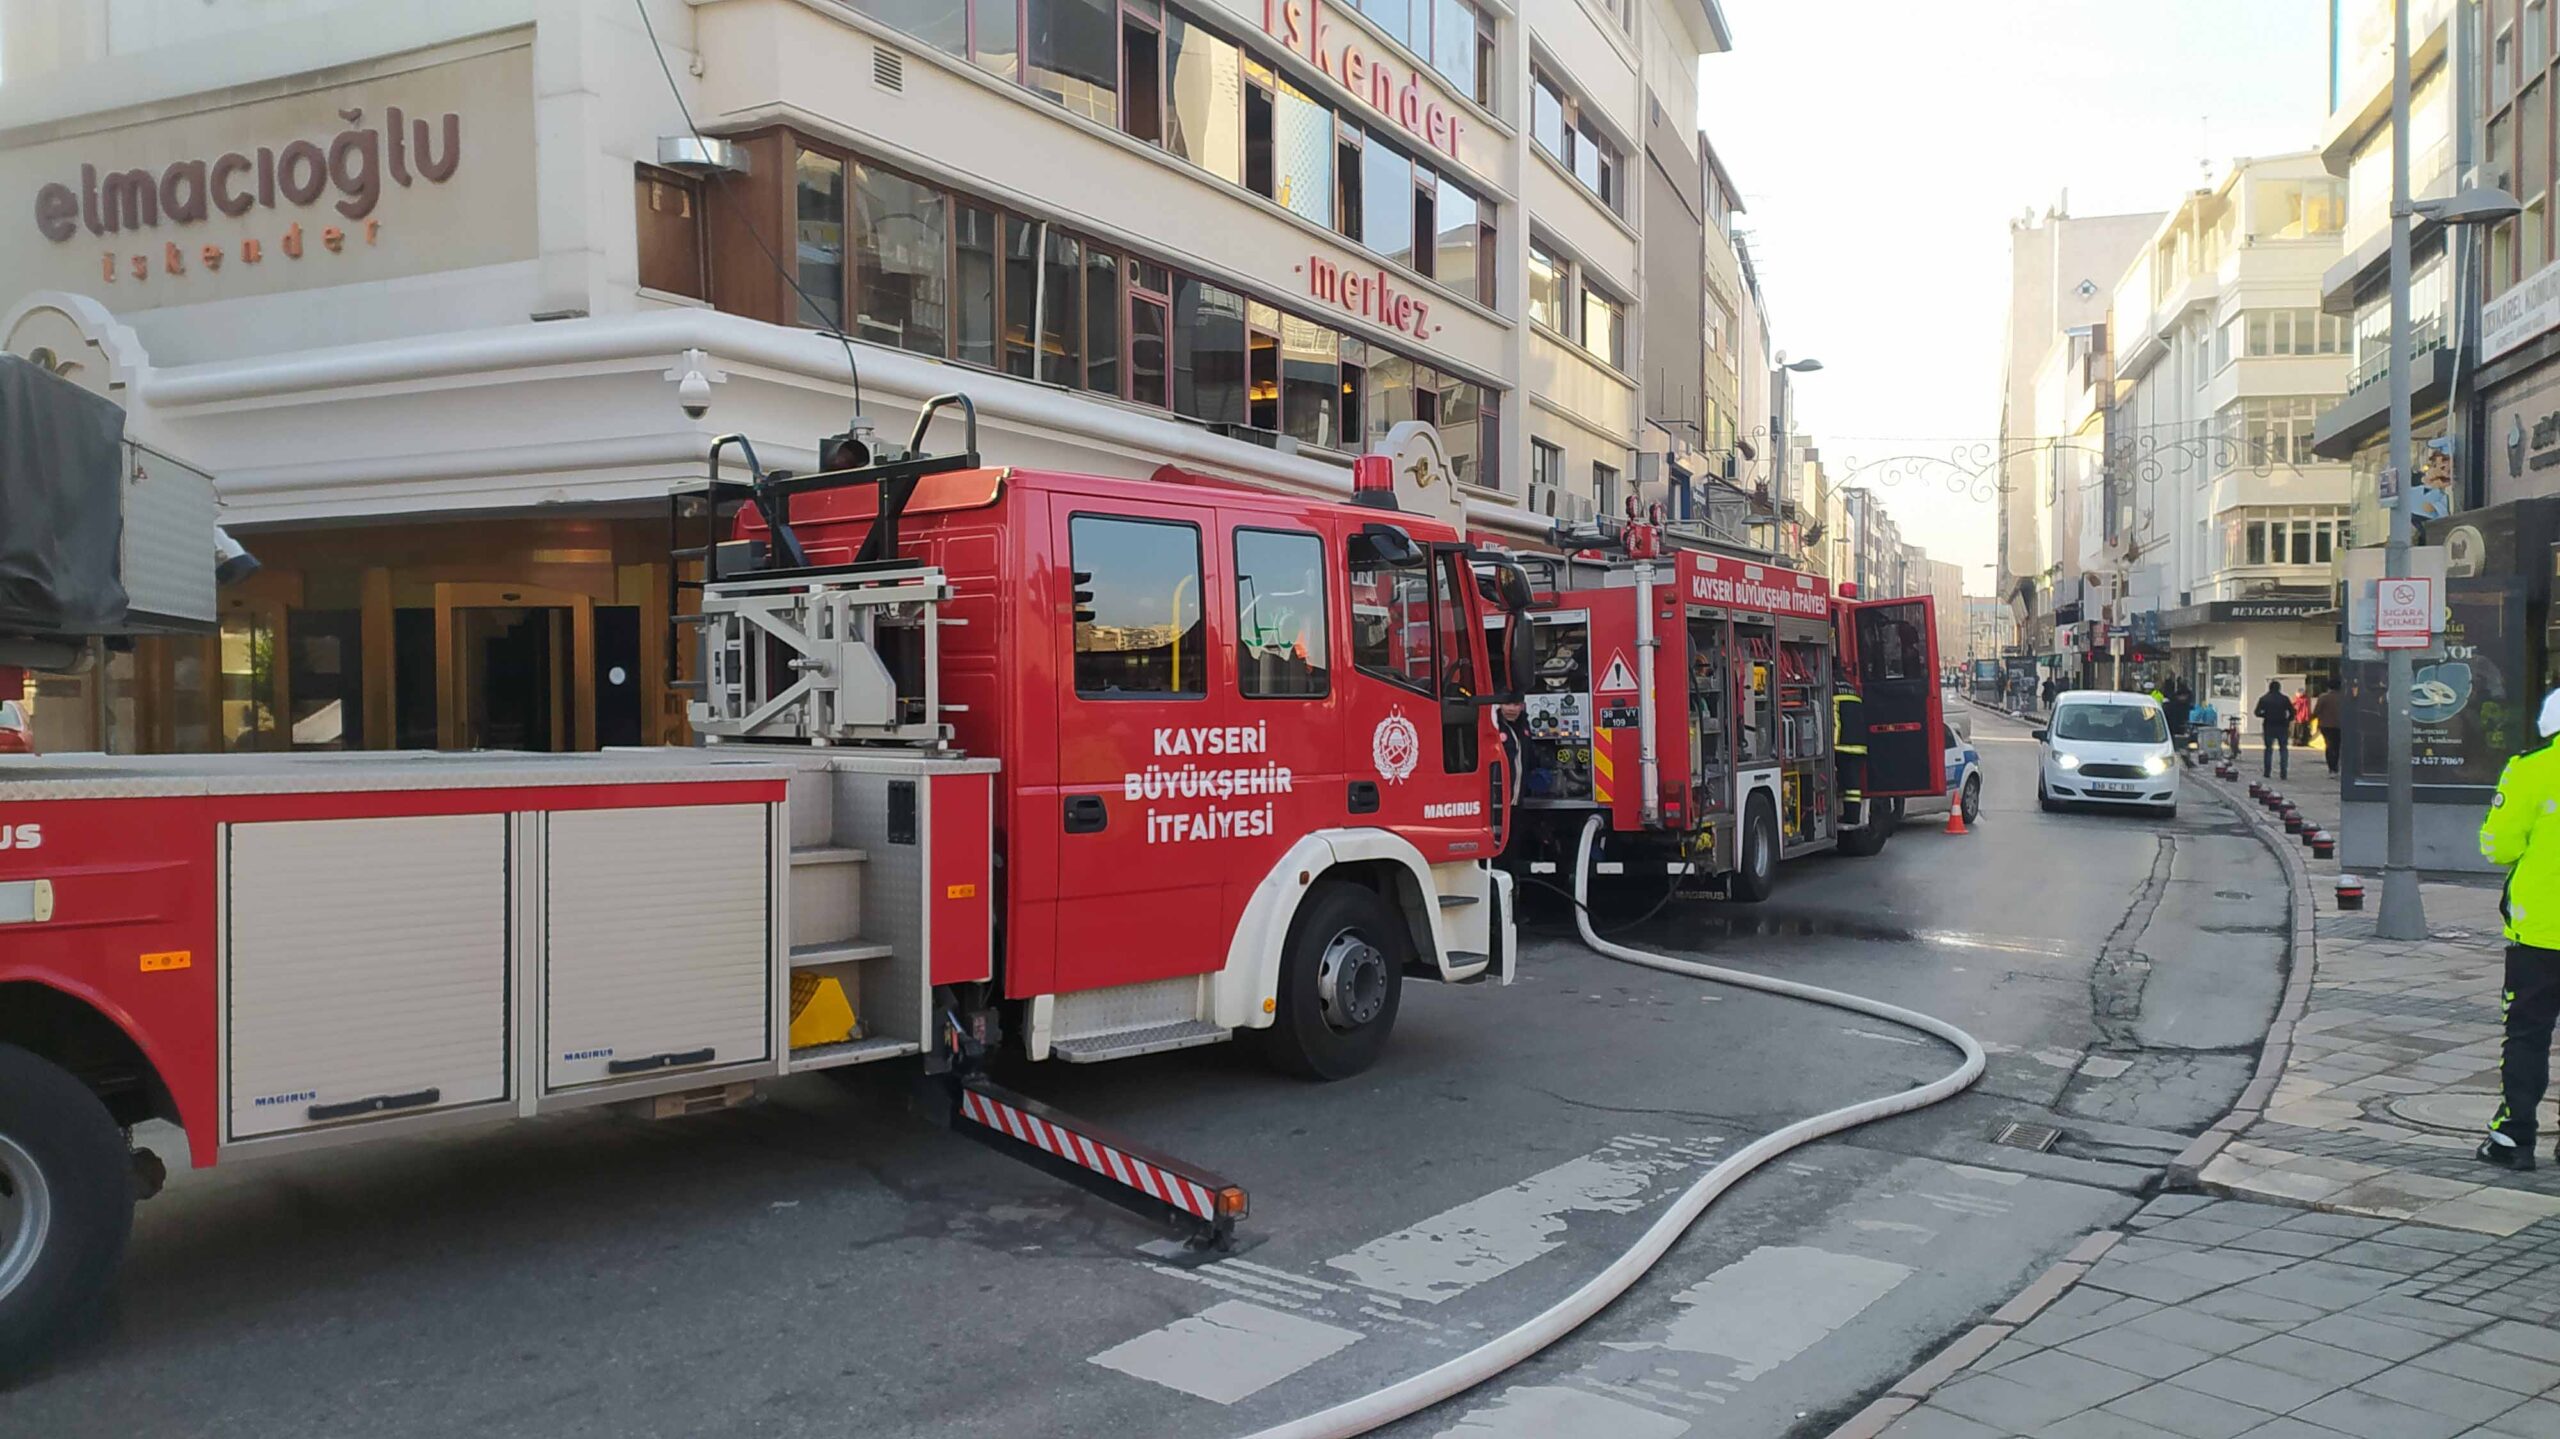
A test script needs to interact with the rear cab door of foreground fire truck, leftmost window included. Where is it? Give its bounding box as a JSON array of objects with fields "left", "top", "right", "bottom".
[{"left": 1050, "top": 497, "right": 1228, "bottom": 991}]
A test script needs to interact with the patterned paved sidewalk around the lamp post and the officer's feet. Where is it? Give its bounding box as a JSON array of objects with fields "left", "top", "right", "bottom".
[{"left": 2189, "top": 755, "right": 2560, "bottom": 1229}]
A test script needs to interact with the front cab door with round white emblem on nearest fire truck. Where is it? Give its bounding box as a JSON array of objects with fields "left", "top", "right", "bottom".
[{"left": 1344, "top": 533, "right": 1508, "bottom": 863}]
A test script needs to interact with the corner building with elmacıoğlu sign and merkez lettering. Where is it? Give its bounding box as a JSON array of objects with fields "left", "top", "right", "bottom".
[{"left": 0, "top": 0, "right": 1728, "bottom": 750}]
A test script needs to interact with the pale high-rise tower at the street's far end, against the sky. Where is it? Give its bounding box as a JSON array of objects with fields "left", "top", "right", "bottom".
[{"left": 1989, "top": 210, "right": 2161, "bottom": 673}]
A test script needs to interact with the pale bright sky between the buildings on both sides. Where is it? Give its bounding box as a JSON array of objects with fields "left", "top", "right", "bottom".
[{"left": 1700, "top": 0, "right": 2330, "bottom": 594}]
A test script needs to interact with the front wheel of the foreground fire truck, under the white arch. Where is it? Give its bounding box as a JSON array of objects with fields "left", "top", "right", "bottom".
[{"left": 1260, "top": 881, "right": 1411, "bottom": 1081}]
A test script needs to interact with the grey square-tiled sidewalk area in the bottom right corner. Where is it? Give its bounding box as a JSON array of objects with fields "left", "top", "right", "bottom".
[{"left": 1851, "top": 1196, "right": 2560, "bottom": 1439}]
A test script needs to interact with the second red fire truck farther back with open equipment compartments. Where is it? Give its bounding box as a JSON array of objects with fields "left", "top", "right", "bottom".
[{"left": 1510, "top": 522, "right": 1943, "bottom": 901}]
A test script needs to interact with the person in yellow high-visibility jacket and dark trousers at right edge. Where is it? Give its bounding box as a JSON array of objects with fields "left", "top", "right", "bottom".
[{"left": 2481, "top": 689, "right": 2560, "bottom": 1170}]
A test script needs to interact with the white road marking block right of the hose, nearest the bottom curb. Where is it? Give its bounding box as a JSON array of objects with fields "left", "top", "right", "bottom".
[{"left": 1661, "top": 1244, "right": 1912, "bottom": 1383}]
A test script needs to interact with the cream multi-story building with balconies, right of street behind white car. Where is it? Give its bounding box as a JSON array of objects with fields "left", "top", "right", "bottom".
[{"left": 2081, "top": 151, "right": 2350, "bottom": 709}]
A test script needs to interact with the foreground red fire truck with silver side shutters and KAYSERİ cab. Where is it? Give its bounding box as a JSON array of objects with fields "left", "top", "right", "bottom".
[{"left": 0, "top": 356, "right": 1528, "bottom": 1367}]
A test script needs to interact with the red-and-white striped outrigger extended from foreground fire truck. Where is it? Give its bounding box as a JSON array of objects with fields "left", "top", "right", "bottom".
[{"left": 942, "top": 1011, "right": 1249, "bottom": 1255}]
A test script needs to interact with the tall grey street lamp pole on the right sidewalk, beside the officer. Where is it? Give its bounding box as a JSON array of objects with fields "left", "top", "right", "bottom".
[{"left": 2373, "top": 0, "right": 2519, "bottom": 940}]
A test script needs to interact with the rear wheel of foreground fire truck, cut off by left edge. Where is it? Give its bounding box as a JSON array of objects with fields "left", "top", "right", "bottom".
[{"left": 0, "top": 1045, "right": 136, "bottom": 1385}]
